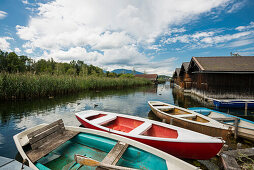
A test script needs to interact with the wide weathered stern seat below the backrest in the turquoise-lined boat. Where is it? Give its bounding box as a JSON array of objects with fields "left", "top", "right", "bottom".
[{"left": 26, "top": 130, "right": 79, "bottom": 162}]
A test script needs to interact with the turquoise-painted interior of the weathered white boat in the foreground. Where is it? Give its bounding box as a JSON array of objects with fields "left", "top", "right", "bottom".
[{"left": 23, "top": 119, "right": 167, "bottom": 170}]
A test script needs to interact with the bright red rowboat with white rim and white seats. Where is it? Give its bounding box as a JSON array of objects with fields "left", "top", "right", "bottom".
[{"left": 76, "top": 110, "right": 224, "bottom": 159}]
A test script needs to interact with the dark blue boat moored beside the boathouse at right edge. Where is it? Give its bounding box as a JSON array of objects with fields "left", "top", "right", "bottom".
[{"left": 213, "top": 99, "right": 254, "bottom": 108}]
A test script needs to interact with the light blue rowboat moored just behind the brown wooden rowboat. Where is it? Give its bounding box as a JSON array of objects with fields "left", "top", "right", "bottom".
[{"left": 188, "top": 107, "right": 254, "bottom": 141}]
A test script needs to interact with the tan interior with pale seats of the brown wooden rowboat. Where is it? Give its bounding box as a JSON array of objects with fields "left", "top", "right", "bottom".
[{"left": 151, "top": 103, "right": 209, "bottom": 123}]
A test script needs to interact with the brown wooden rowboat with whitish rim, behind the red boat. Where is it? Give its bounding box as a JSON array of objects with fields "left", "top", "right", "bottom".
[{"left": 148, "top": 101, "right": 232, "bottom": 140}]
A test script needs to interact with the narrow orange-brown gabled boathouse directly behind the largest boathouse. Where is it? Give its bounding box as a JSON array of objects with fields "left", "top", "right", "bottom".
[{"left": 179, "top": 62, "right": 191, "bottom": 89}]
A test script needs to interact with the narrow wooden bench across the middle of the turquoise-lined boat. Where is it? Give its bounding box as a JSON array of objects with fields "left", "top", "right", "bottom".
[{"left": 96, "top": 141, "right": 129, "bottom": 170}]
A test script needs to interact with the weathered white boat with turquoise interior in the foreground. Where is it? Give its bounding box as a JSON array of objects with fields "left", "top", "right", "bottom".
[{"left": 13, "top": 120, "right": 198, "bottom": 170}]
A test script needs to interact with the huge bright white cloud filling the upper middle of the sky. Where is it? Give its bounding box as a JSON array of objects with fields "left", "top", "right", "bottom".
[{"left": 16, "top": 0, "right": 229, "bottom": 74}]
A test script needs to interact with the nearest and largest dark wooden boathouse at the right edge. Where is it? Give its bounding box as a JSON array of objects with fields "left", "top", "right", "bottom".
[{"left": 187, "top": 56, "right": 254, "bottom": 98}]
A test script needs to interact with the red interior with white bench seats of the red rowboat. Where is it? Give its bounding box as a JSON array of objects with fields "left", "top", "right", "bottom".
[{"left": 86, "top": 114, "right": 178, "bottom": 138}]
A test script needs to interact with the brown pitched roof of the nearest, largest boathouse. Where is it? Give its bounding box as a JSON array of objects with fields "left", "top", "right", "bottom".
[{"left": 188, "top": 56, "right": 254, "bottom": 73}]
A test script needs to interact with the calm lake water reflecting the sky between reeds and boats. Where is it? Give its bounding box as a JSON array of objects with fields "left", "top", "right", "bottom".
[{"left": 0, "top": 83, "right": 254, "bottom": 158}]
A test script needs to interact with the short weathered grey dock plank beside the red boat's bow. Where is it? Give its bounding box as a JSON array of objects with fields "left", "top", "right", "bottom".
[{"left": 221, "top": 153, "right": 241, "bottom": 170}]
